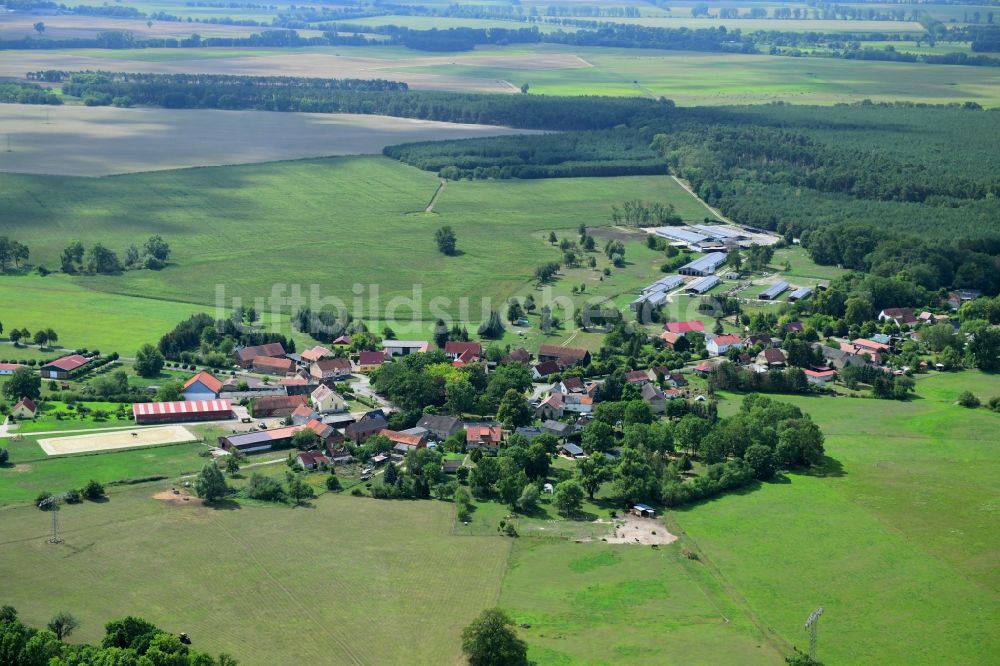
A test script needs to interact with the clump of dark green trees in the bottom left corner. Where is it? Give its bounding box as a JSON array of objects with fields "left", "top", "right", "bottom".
[{"left": 0, "top": 606, "right": 238, "bottom": 666}]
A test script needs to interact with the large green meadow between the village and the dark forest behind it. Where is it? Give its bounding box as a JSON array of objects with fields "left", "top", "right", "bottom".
[{"left": 0, "top": 158, "right": 697, "bottom": 338}]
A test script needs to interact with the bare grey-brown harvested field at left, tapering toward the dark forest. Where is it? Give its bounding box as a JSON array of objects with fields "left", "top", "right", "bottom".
[{"left": 0, "top": 104, "right": 540, "bottom": 176}]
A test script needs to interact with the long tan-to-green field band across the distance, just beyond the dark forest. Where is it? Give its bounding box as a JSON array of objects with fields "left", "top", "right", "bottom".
[{"left": 0, "top": 41, "right": 1000, "bottom": 107}]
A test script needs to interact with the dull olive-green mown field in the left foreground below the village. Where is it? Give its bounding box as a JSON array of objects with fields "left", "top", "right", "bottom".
[{"left": 0, "top": 487, "right": 510, "bottom": 666}]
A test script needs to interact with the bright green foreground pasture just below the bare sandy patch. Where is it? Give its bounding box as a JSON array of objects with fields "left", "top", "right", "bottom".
[{"left": 500, "top": 538, "right": 782, "bottom": 664}]
